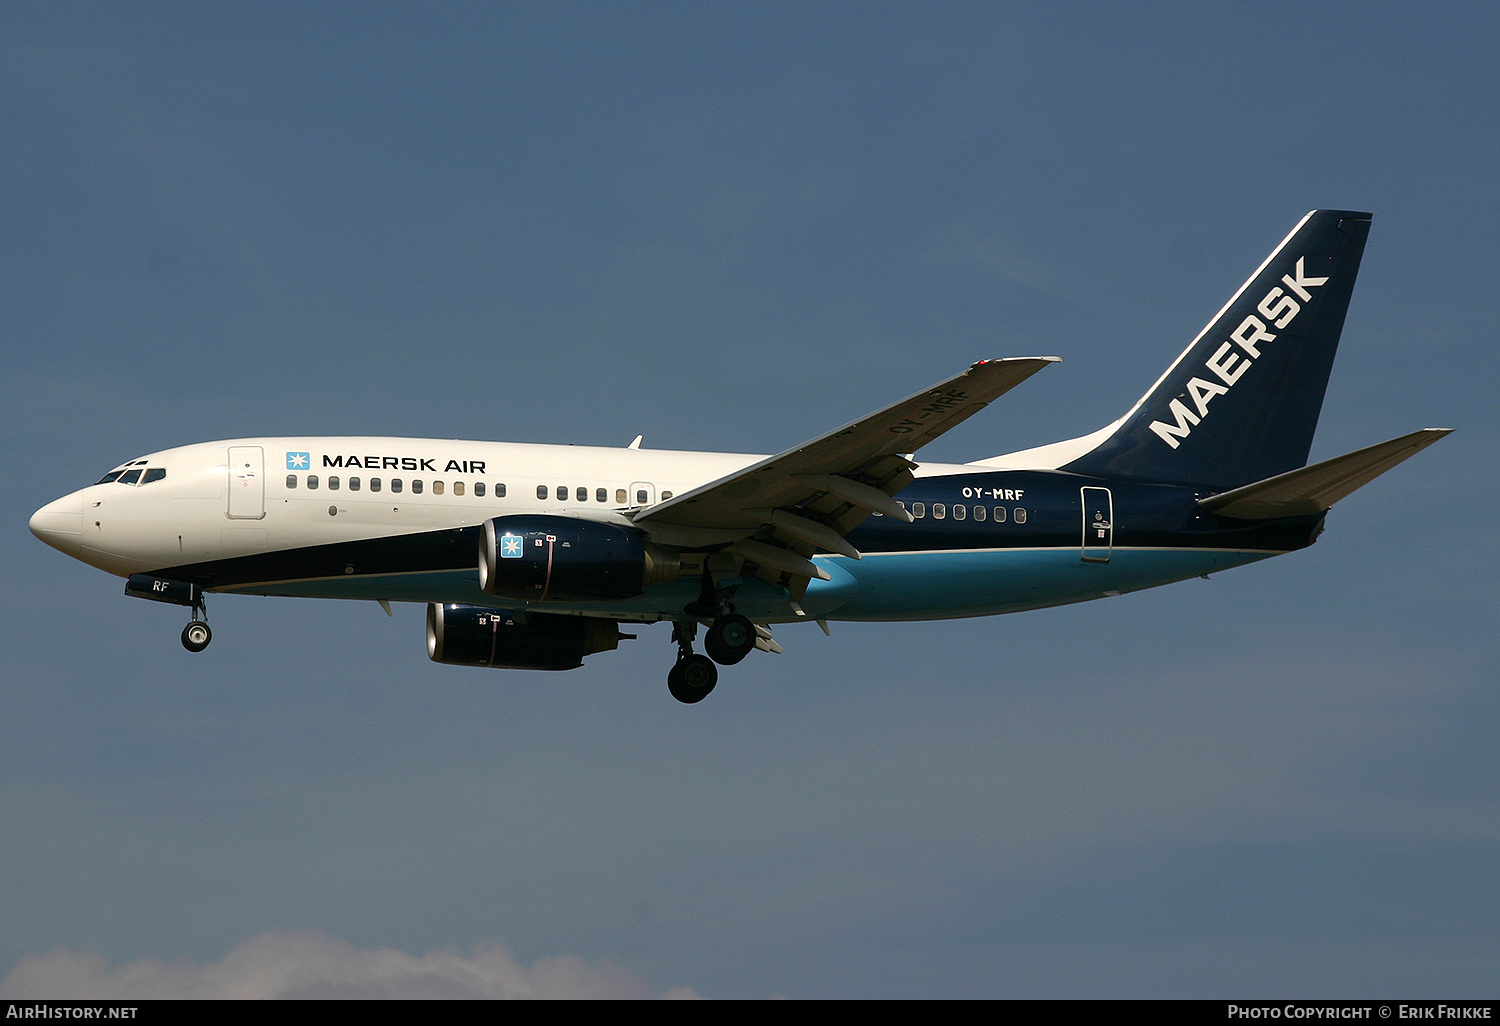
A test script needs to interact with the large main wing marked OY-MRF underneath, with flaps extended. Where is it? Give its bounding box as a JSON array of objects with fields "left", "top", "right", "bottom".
[{"left": 635, "top": 357, "right": 1058, "bottom": 594}]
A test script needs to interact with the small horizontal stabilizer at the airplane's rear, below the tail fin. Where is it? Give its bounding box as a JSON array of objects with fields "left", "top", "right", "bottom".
[{"left": 1199, "top": 428, "right": 1452, "bottom": 521}]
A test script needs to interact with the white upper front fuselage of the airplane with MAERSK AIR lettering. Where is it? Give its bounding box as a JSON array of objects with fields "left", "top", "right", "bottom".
[{"left": 32, "top": 437, "right": 965, "bottom": 578}]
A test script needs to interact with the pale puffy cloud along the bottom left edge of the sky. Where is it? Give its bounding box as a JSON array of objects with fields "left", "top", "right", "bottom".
[{"left": 0, "top": 930, "right": 699, "bottom": 1001}]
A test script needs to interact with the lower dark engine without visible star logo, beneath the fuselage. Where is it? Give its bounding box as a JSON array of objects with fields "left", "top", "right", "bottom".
[{"left": 428, "top": 603, "right": 621, "bottom": 669}]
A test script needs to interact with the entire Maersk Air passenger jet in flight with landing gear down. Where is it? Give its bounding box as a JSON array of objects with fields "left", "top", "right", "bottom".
[{"left": 30, "top": 210, "right": 1451, "bottom": 704}]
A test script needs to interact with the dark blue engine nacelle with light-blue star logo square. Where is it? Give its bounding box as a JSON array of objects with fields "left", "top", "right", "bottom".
[{"left": 479, "top": 513, "right": 681, "bottom": 602}]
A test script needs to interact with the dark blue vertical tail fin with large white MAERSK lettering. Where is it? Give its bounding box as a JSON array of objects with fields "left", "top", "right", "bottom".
[{"left": 1061, "top": 210, "right": 1371, "bottom": 489}]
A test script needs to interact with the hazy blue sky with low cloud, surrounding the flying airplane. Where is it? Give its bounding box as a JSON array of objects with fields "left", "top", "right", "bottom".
[{"left": 0, "top": 3, "right": 1500, "bottom": 998}]
